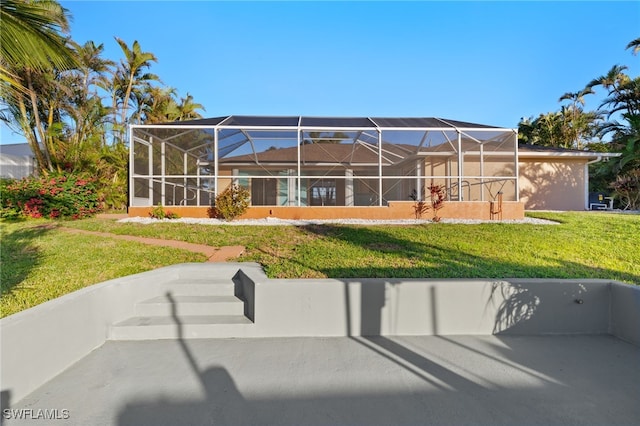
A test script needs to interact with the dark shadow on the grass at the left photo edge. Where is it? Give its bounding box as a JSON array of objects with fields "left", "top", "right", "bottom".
[{"left": 0, "top": 222, "right": 57, "bottom": 296}]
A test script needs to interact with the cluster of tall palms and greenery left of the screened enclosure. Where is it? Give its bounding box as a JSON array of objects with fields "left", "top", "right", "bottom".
[{"left": 0, "top": 0, "right": 203, "bottom": 209}]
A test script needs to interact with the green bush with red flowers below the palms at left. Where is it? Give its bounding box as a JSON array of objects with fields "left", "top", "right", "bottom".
[{"left": 0, "top": 173, "right": 102, "bottom": 219}]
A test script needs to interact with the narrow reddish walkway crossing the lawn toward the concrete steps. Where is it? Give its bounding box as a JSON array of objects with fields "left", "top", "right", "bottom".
[{"left": 59, "top": 227, "right": 244, "bottom": 262}]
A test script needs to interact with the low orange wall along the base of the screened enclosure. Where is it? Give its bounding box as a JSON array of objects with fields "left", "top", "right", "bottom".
[{"left": 129, "top": 201, "right": 524, "bottom": 220}]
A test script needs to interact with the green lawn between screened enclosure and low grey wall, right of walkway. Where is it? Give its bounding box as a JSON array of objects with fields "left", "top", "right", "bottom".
[{"left": 62, "top": 212, "right": 640, "bottom": 284}]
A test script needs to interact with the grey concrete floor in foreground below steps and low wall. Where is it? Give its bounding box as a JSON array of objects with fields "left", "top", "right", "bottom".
[{"left": 3, "top": 335, "right": 640, "bottom": 426}]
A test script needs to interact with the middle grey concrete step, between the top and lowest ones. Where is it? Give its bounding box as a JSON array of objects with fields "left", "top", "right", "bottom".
[{"left": 136, "top": 294, "right": 244, "bottom": 317}]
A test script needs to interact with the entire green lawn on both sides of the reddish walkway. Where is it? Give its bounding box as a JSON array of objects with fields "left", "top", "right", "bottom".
[{"left": 0, "top": 212, "right": 640, "bottom": 316}]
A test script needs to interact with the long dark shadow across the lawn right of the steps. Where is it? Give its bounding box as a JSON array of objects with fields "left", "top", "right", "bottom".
[{"left": 296, "top": 225, "right": 640, "bottom": 284}]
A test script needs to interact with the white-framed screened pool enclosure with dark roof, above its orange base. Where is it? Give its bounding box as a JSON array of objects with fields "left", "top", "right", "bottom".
[{"left": 130, "top": 116, "right": 518, "bottom": 207}]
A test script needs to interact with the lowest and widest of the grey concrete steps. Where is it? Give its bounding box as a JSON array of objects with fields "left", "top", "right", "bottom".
[{"left": 109, "top": 315, "right": 253, "bottom": 340}]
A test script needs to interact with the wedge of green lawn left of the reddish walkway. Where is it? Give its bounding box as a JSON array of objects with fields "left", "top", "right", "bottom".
[{"left": 0, "top": 221, "right": 205, "bottom": 317}]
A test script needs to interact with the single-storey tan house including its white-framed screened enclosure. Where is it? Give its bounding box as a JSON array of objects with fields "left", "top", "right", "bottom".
[{"left": 129, "top": 116, "right": 616, "bottom": 219}]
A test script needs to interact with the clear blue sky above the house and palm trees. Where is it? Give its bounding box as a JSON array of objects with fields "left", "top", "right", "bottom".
[{"left": 0, "top": 0, "right": 640, "bottom": 143}]
